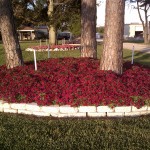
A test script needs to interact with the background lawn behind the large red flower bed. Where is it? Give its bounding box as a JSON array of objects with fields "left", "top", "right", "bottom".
[{"left": 0, "top": 41, "right": 150, "bottom": 66}]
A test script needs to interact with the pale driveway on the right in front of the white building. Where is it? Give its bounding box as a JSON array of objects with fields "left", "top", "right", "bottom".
[{"left": 123, "top": 43, "right": 150, "bottom": 53}]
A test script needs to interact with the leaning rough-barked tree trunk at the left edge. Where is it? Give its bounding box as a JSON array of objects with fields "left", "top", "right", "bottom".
[{"left": 0, "top": 0, "right": 23, "bottom": 68}]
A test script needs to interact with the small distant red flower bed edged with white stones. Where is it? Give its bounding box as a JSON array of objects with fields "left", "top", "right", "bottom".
[{"left": 26, "top": 44, "right": 80, "bottom": 52}]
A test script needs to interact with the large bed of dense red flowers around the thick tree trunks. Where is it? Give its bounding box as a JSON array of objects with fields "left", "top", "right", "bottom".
[{"left": 0, "top": 58, "right": 150, "bottom": 108}]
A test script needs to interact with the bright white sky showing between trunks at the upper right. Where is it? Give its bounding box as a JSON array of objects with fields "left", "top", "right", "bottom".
[{"left": 97, "top": 0, "right": 150, "bottom": 27}]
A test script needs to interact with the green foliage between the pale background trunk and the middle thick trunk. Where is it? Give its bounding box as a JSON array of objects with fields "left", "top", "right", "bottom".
[{"left": 49, "top": 0, "right": 81, "bottom": 43}]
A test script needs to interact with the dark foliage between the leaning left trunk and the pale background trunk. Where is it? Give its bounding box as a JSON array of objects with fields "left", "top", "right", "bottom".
[{"left": 12, "top": 0, "right": 48, "bottom": 27}]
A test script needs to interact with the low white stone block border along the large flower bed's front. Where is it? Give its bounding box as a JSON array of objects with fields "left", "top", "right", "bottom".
[{"left": 0, "top": 100, "right": 150, "bottom": 118}]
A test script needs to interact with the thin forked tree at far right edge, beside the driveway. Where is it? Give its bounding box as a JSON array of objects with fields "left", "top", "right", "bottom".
[{"left": 137, "top": 0, "right": 150, "bottom": 44}]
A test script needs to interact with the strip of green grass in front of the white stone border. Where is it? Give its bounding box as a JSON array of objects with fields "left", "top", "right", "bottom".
[{"left": 0, "top": 113, "right": 150, "bottom": 150}]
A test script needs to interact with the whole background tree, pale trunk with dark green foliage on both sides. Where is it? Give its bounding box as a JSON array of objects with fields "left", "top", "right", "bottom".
[{"left": 13, "top": 0, "right": 81, "bottom": 44}]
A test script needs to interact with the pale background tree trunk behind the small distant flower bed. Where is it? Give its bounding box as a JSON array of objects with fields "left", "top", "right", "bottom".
[{"left": 47, "top": 0, "right": 56, "bottom": 45}]
